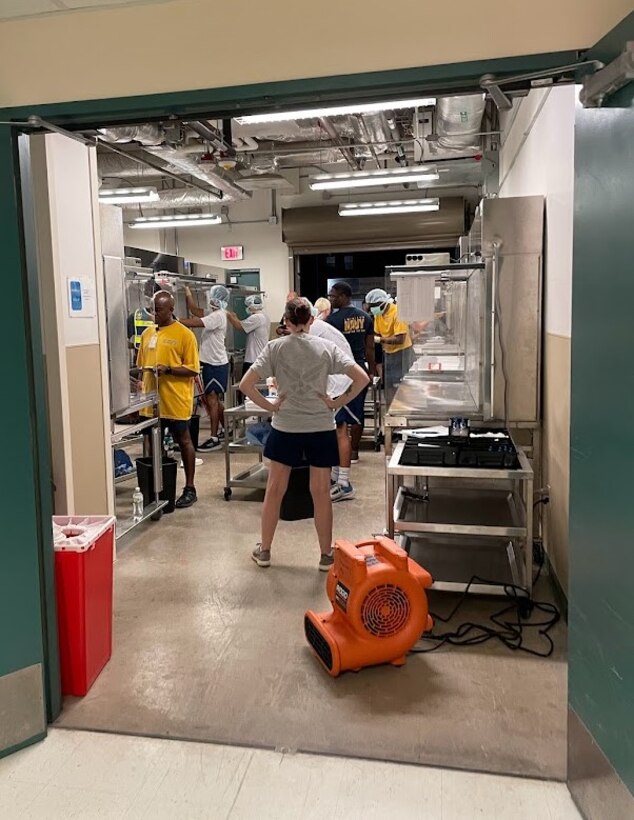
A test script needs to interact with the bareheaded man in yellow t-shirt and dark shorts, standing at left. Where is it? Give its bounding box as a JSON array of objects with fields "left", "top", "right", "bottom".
[{"left": 137, "top": 291, "right": 200, "bottom": 509}]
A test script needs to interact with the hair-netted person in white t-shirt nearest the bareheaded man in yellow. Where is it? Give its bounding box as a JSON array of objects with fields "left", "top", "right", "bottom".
[{"left": 181, "top": 285, "right": 229, "bottom": 453}]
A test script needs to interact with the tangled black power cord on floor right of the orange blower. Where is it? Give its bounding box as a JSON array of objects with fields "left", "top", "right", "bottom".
[{"left": 410, "top": 553, "right": 561, "bottom": 658}]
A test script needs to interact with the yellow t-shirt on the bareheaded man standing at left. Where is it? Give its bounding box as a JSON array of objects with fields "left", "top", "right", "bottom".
[{"left": 137, "top": 322, "right": 200, "bottom": 421}]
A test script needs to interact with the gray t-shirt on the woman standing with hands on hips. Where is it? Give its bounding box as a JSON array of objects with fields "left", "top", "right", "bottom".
[{"left": 253, "top": 333, "right": 354, "bottom": 433}]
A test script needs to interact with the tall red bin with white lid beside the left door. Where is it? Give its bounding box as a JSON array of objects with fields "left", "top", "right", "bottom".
[{"left": 53, "top": 516, "right": 115, "bottom": 695}]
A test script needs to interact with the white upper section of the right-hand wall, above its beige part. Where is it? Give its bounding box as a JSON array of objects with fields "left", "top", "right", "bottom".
[{"left": 500, "top": 86, "right": 576, "bottom": 338}]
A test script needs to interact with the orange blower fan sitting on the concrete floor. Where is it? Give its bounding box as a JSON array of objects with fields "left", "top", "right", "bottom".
[{"left": 304, "top": 538, "right": 433, "bottom": 677}]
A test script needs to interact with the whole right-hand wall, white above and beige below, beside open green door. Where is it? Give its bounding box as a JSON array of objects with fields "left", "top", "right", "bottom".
[{"left": 500, "top": 86, "right": 576, "bottom": 590}]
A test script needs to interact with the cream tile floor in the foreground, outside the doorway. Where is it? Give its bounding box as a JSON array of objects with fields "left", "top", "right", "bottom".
[{"left": 0, "top": 729, "right": 580, "bottom": 820}]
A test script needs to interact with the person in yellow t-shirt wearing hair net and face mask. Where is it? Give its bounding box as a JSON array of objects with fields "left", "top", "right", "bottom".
[{"left": 365, "top": 288, "right": 412, "bottom": 408}]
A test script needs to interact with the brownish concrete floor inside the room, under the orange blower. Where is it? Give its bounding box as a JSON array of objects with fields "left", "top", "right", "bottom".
[{"left": 58, "top": 432, "right": 566, "bottom": 779}]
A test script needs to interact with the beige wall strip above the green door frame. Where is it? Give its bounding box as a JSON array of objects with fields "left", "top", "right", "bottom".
[{"left": 0, "top": 0, "right": 632, "bottom": 106}]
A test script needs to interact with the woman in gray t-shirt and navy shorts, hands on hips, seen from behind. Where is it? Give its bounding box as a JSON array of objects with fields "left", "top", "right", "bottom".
[{"left": 240, "top": 298, "right": 368, "bottom": 571}]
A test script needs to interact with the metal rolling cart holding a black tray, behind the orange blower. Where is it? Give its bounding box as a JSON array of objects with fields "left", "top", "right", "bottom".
[{"left": 386, "top": 442, "right": 533, "bottom": 595}]
